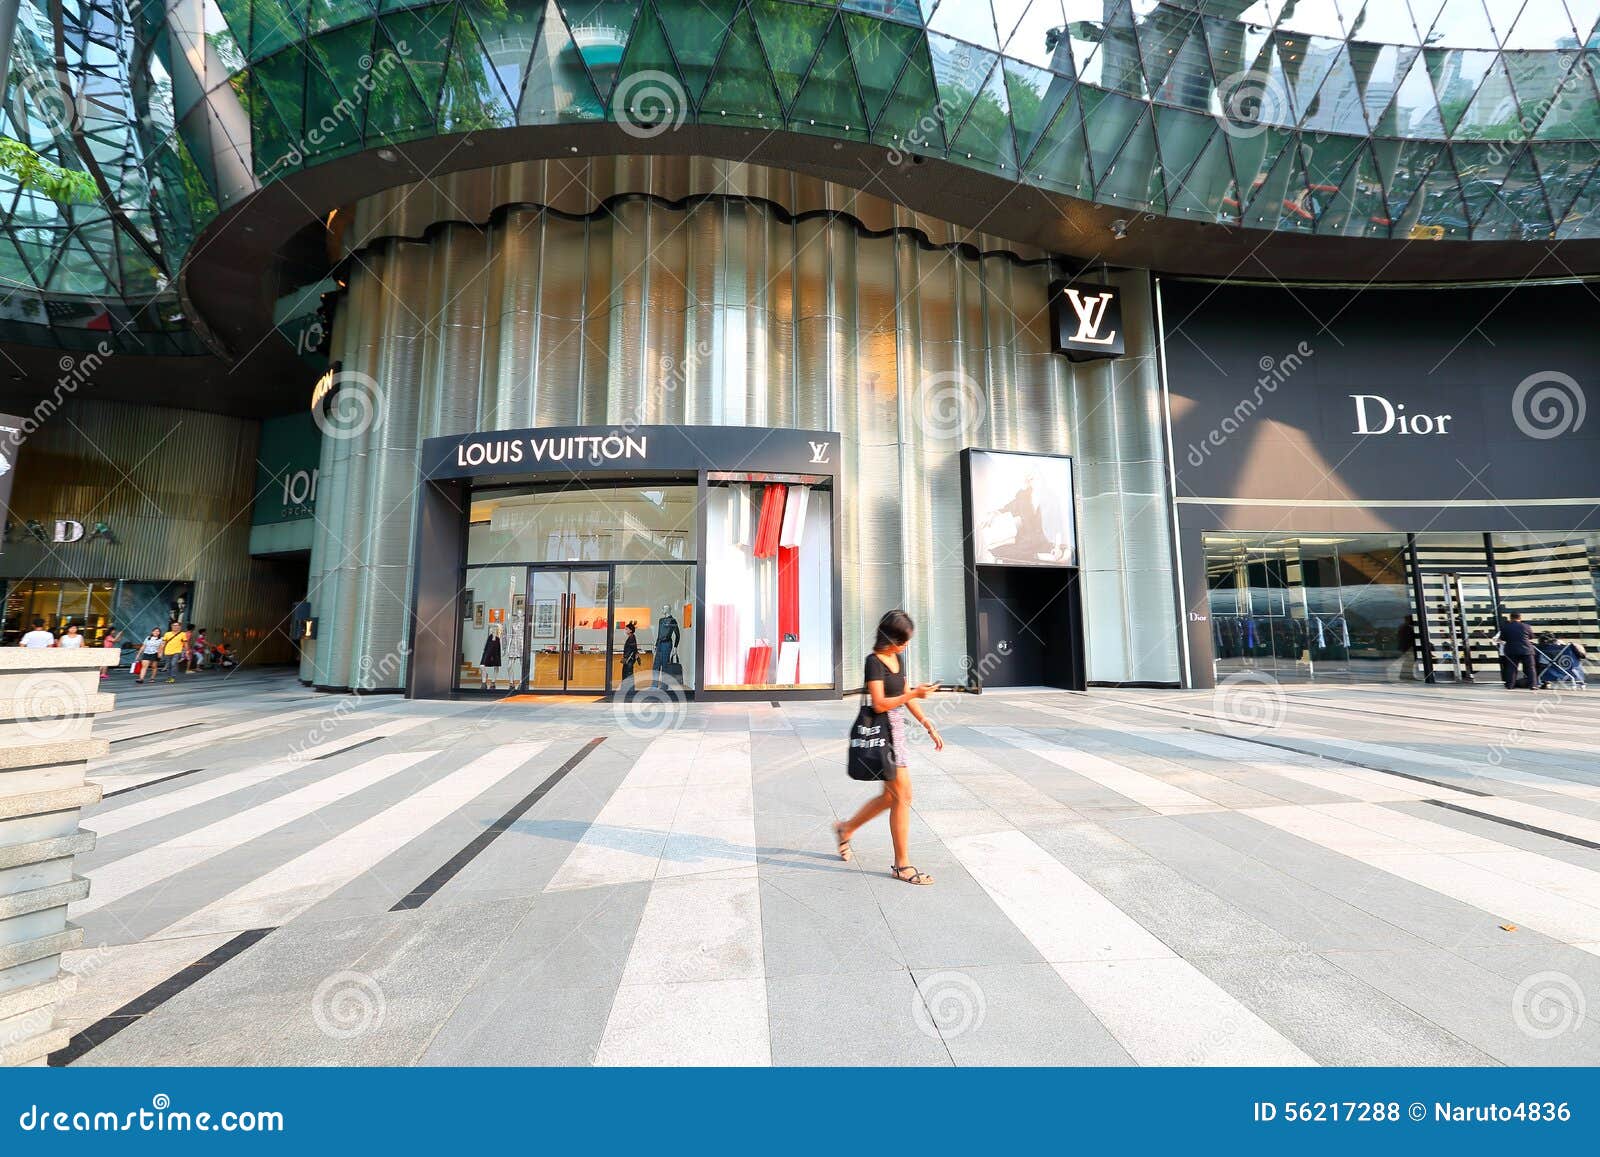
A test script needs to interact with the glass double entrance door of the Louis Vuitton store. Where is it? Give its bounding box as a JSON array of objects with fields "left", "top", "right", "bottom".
[{"left": 523, "top": 566, "right": 621, "bottom": 691}]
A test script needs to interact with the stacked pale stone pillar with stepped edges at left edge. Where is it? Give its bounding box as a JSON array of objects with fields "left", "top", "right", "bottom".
[{"left": 0, "top": 647, "right": 117, "bottom": 1066}]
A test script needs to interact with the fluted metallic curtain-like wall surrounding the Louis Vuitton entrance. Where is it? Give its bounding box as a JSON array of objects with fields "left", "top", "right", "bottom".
[{"left": 302, "top": 162, "right": 1178, "bottom": 687}]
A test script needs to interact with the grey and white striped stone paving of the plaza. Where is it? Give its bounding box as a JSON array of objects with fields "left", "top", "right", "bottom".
[{"left": 53, "top": 674, "right": 1600, "bottom": 1066}]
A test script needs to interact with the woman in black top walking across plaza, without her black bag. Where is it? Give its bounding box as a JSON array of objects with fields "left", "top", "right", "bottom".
[{"left": 834, "top": 611, "right": 944, "bottom": 883}]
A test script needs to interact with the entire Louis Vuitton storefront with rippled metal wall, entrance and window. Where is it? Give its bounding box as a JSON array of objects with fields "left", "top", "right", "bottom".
[{"left": 301, "top": 158, "right": 1179, "bottom": 699}]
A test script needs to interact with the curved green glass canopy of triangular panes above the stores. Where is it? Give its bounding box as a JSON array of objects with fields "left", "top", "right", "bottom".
[{"left": 150, "top": 0, "right": 1600, "bottom": 251}]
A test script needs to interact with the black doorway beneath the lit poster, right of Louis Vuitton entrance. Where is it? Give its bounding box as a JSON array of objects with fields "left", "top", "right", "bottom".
[{"left": 971, "top": 566, "right": 1085, "bottom": 691}]
